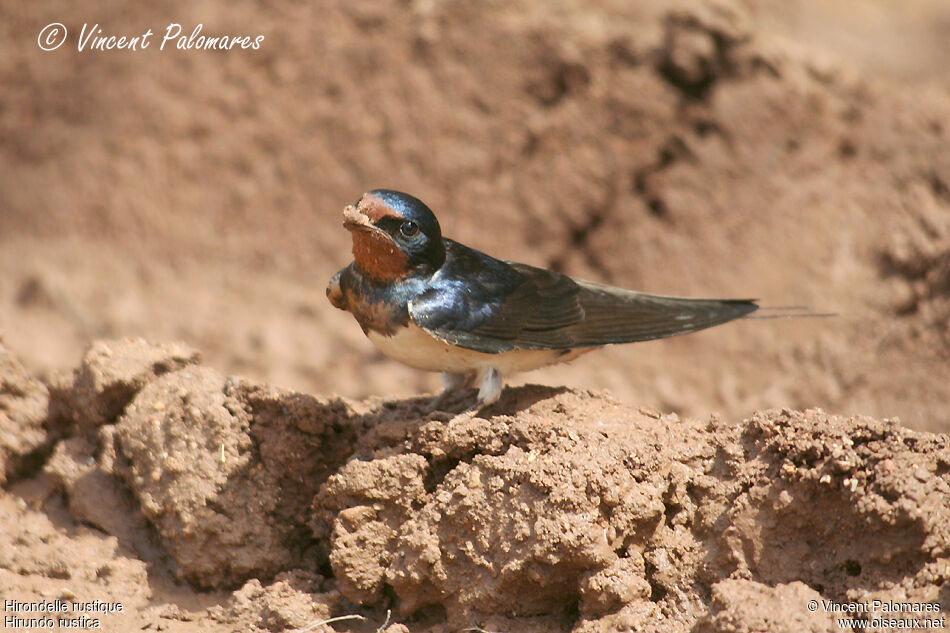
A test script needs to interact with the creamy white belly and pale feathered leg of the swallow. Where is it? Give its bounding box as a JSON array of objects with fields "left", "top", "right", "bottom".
[{"left": 367, "top": 321, "right": 595, "bottom": 404}]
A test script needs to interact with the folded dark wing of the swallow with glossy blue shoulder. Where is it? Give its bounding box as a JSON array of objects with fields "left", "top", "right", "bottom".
[{"left": 409, "top": 256, "right": 758, "bottom": 353}]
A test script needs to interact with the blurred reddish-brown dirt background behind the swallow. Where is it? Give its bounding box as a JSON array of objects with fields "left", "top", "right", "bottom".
[{"left": 0, "top": 0, "right": 950, "bottom": 430}]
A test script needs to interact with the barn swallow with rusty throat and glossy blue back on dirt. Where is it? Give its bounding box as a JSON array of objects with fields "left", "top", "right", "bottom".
[{"left": 327, "top": 189, "right": 808, "bottom": 407}]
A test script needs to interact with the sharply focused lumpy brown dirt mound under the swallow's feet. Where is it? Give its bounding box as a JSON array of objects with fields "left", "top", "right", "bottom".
[{"left": 0, "top": 340, "right": 950, "bottom": 633}]
